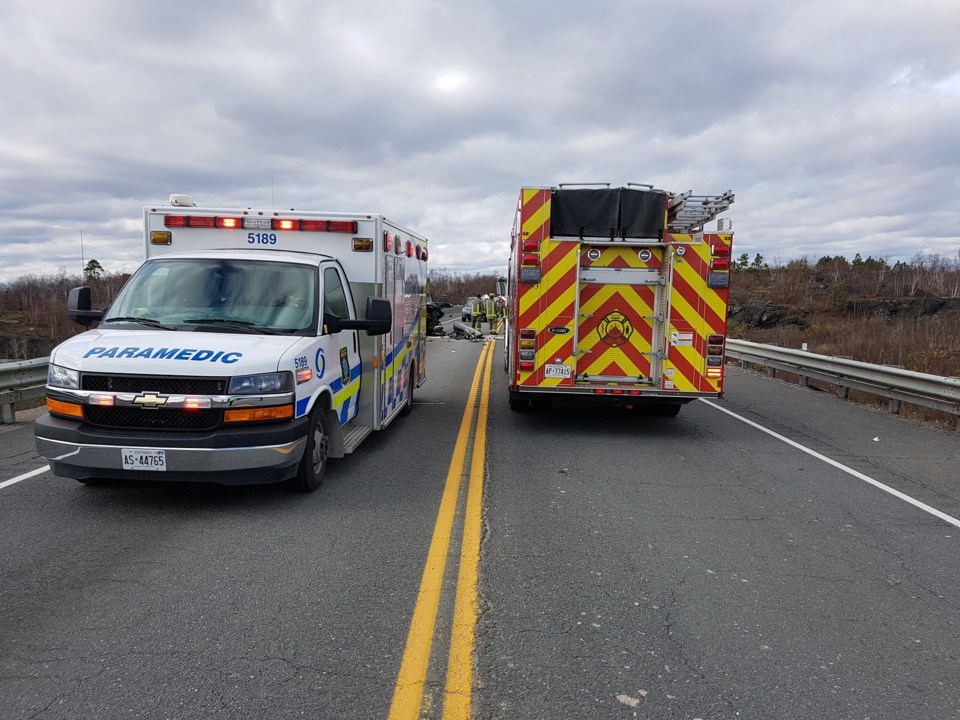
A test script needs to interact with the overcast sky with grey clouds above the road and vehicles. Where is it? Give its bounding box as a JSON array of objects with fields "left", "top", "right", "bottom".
[{"left": 0, "top": 0, "right": 960, "bottom": 281}]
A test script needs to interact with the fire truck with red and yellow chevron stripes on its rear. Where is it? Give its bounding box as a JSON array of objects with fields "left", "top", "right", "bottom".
[{"left": 504, "top": 183, "right": 734, "bottom": 416}]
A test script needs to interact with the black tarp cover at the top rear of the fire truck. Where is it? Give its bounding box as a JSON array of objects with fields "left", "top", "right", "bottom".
[{"left": 550, "top": 188, "right": 667, "bottom": 240}]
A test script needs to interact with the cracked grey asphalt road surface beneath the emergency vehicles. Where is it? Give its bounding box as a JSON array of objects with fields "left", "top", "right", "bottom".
[{"left": 0, "top": 330, "right": 960, "bottom": 720}]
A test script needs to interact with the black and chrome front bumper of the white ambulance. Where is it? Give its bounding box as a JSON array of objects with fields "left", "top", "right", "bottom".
[{"left": 34, "top": 413, "right": 309, "bottom": 485}]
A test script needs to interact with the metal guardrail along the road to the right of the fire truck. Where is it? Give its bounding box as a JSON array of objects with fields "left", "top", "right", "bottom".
[{"left": 727, "top": 340, "right": 960, "bottom": 429}]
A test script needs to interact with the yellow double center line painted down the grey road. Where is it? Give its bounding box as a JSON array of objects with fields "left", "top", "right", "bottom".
[{"left": 388, "top": 342, "right": 495, "bottom": 720}]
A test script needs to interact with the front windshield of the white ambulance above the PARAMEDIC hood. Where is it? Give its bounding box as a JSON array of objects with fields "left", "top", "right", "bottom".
[{"left": 102, "top": 258, "right": 317, "bottom": 334}]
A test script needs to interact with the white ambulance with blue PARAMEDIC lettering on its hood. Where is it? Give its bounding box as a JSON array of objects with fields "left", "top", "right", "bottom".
[{"left": 35, "top": 195, "right": 428, "bottom": 491}]
